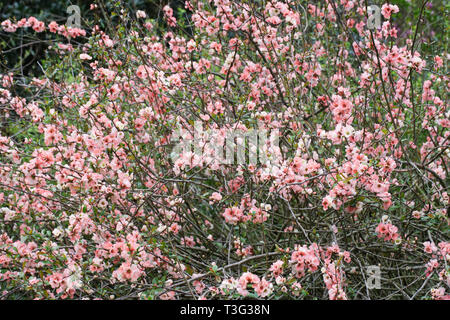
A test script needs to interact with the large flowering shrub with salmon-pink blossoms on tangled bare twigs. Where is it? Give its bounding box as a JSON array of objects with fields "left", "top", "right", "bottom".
[{"left": 0, "top": 0, "right": 450, "bottom": 299}]
